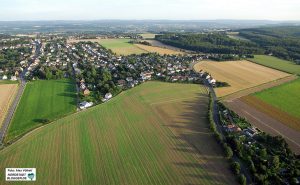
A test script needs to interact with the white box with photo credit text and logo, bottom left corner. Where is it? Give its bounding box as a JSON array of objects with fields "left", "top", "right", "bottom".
[{"left": 5, "top": 168, "right": 36, "bottom": 181}]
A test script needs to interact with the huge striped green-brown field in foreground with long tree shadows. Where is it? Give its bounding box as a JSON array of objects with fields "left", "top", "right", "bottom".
[{"left": 0, "top": 82, "right": 237, "bottom": 185}]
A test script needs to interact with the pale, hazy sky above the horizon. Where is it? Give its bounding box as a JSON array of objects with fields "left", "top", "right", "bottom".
[{"left": 0, "top": 0, "right": 300, "bottom": 21}]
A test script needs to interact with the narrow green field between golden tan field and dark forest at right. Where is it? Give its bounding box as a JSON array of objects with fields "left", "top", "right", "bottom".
[{"left": 249, "top": 55, "right": 300, "bottom": 75}]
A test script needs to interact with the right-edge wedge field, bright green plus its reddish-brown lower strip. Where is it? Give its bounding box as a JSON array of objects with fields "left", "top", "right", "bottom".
[{"left": 245, "top": 79, "right": 300, "bottom": 131}]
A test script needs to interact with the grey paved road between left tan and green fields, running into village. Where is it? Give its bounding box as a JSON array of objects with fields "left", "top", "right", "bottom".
[{"left": 0, "top": 42, "right": 41, "bottom": 144}]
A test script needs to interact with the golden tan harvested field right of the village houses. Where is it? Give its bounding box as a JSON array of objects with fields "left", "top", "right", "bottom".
[{"left": 194, "top": 61, "right": 290, "bottom": 97}]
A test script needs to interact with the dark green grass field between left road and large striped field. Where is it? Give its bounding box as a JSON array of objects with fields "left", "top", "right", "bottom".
[{"left": 5, "top": 79, "right": 76, "bottom": 141}]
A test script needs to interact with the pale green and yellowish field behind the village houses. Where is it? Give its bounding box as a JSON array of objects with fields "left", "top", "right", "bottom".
[{"left": 98, "top": 39, "right": 148, "bottom": 55}]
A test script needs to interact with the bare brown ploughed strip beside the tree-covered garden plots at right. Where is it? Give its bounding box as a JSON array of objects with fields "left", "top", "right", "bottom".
[{"left": 224, "top": 99, "right": 300, "bottom": 154}]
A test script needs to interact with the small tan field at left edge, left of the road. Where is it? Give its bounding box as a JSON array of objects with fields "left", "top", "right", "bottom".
[{"left": 0, "top": 82, "right": 18, "bottom": 127}]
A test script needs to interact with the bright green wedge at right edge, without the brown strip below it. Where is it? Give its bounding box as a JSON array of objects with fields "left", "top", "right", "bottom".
[{"left": 255, "top": 79, "right": 300, "bottom": 118}]
